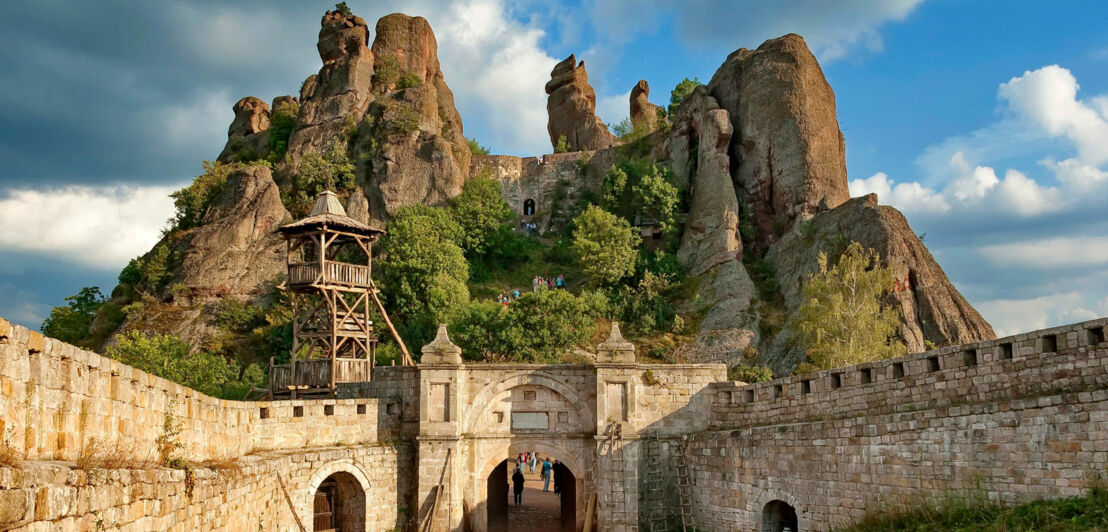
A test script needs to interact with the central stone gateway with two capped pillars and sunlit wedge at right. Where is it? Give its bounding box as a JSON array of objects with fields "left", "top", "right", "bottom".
[{"left": 417, "top": 326, "right": 726, "bottom": 531}]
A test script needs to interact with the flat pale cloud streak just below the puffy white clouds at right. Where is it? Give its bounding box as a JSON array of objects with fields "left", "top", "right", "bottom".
[{"left": 979, "top": 236, "right": 1108, "bottom": 270}]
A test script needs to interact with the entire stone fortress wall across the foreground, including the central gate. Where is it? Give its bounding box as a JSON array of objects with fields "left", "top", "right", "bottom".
[{"left": 0, "top": 319, "right": 1108, "bottom": 531}]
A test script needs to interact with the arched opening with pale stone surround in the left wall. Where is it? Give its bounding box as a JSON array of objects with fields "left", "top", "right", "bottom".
[{"left": 302, "top": 459, "right": 369, "bottom": 532}]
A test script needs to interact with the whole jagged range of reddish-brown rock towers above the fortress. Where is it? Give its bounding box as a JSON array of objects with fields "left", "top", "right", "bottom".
[{"left": 84, "top": 5, "right": 993, "bottom": 374}]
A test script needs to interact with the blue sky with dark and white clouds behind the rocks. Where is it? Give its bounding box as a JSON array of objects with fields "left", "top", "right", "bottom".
[{"left": 0, "top": 0, "right": 1108, "bottom": 335}]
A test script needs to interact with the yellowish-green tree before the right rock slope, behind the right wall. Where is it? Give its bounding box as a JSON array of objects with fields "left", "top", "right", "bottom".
[{"left": 790, "top": 242, "right": 906, "bottom": 371}]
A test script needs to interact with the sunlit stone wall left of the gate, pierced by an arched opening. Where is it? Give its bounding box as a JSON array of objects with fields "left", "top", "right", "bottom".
[{"left": 0, "top": 319, "right": 419, "bottom": 531}]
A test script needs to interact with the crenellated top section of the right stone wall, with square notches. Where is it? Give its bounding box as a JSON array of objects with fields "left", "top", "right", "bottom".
[{"left": 711, "top": 318, "right": 1108, "bottom": 428}]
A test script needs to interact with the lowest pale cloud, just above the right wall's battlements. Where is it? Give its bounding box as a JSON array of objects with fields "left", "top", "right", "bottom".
[{"left": 977, "top": 291, "right": 1099, "bottom": 336}]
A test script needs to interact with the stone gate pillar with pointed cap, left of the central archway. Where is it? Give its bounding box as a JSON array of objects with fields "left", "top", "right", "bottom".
[{"left": 417, "top": 325, "right": 464, "bottom": 531}]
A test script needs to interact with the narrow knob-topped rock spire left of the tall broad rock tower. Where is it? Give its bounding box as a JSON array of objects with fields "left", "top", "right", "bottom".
[{"left": 287, "top": 11, "right": 373, "bottom": 161}]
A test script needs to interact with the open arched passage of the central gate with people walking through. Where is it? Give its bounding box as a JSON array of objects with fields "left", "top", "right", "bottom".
[{"left": 485, "top": 453, "right": 577, "bottom": 532}]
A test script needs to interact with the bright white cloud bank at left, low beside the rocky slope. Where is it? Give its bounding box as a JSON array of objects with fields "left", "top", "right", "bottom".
[{"left": 0, "top": 186, "right": 174, "bottom": 269}]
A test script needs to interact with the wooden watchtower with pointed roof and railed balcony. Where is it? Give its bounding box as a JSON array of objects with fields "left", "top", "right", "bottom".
[{"left": 269, "top": 191, "right": 411, "bottom": 398}]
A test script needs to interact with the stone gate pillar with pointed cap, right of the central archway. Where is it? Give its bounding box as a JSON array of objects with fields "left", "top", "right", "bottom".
[{"left": 596, "top": 323, "right": 639, "bottom": 532}]
